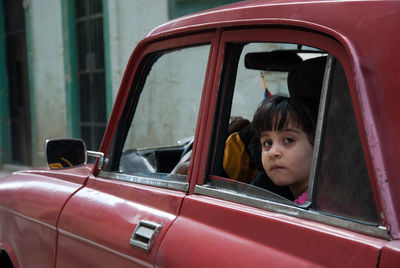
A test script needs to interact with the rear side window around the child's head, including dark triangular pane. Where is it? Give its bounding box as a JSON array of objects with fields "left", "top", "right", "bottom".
[{"left": 202, "top": 37, "right": 379, "bottom": 232}]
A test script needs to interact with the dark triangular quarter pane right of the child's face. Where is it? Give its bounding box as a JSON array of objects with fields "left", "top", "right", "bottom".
[{"left": 313, "top": 61, "right": 379, "bottom": 224}]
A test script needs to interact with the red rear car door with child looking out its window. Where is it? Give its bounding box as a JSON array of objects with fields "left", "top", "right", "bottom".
[{"left": 156, "top": 27, "right": 389, "bottom": 267}]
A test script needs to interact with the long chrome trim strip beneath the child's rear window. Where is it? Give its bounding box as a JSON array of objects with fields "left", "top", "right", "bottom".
[{"left": 194, "top": 185, "right": 391, "bottom": 240}]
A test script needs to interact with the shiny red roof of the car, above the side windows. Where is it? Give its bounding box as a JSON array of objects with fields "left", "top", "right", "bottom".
[{"left": 148, "top": 0, "right": 400, "bottom": 39}]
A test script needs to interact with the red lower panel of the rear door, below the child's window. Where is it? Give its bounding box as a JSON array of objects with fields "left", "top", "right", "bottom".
[{"left": 156, "top": 195, "right": 386, "bottom": 267}]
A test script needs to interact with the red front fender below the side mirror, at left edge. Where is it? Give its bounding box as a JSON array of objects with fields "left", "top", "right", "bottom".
[{"left": 0, "top": 166, "right": 91, "bottom": 267}]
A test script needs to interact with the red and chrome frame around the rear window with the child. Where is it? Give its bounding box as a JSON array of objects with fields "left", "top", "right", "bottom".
[{"left": 193, "top": 27, "right": 390, "bottom": 239}]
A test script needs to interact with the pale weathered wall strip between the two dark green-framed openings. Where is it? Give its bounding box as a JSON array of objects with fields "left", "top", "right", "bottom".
[{"left": 28, "top": 0, "right": 67, "bottom": 166}]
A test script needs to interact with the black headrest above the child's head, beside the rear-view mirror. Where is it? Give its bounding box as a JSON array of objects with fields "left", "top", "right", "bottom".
[{"left": 287, "top": 56, "right": 327, "bottom": 102}]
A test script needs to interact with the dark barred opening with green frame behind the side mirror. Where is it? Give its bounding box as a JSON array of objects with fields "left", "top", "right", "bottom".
[{"left": 75, "top": 0, "right": 107, "bottom": 150}]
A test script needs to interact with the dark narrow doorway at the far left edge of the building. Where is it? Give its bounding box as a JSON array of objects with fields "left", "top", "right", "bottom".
[{"left": 2, "top": 0, "right": 32, "bottom": 165}]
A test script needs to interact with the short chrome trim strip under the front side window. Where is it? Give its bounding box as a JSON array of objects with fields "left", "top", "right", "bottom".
[{"left": 99, "top": 170, "right": 189, "bottom": 192}]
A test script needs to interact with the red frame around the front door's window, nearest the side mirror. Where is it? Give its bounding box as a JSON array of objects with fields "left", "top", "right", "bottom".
[{"left": 97, "top": 31, "right": 217, "bottom": 192}]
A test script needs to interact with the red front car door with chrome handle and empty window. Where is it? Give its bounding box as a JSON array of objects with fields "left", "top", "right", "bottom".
[{"left": 57, "top": 32, "right": 214, "bottom": 267}]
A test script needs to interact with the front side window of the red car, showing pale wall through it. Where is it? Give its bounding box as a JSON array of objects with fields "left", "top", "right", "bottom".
[{"left": 108, "top": 45, "right": 210, "bottom": 186}]
